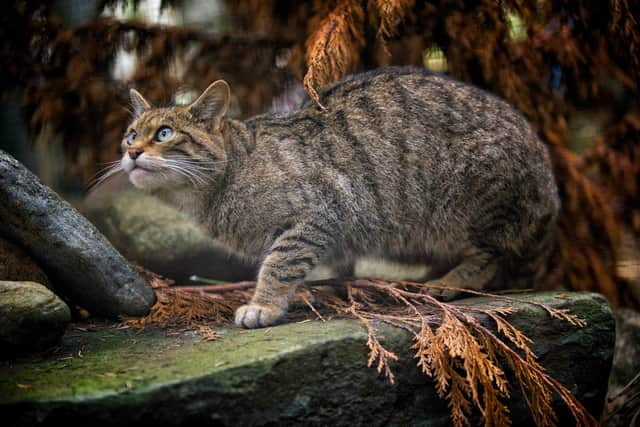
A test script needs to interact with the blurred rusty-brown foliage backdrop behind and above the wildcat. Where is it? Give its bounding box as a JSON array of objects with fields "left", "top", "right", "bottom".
[{"left": 0, "top": 0, "right": 640, "bottom": 307}]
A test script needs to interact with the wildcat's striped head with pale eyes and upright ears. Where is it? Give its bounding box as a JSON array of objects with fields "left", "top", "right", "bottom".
[{"left": 120, "top": 80, "right": 229, "bottom": 191}]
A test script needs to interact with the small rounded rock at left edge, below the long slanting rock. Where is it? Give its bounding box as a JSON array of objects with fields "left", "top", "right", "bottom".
[{"left": 0, "top": 281, "right": 71, "bottom": 358}]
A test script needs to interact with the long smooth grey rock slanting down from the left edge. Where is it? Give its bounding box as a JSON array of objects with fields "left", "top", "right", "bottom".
[{"left": 0, "top": 150, "right": 155, "bottom": 316}]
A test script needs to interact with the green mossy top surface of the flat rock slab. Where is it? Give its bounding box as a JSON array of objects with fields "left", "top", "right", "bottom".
[{"left": 0, "top": 321, "right": 364, "bottom": 403}]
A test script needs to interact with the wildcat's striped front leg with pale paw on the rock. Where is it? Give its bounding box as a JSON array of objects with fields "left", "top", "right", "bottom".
[{"left": 235, "top": 226, "right": 328, "bottom": 328}]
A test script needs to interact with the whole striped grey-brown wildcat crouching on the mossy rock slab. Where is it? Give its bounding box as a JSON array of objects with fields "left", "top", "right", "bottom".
[{"left": 120, "top": 67, "right": 559, "bottom": 328}]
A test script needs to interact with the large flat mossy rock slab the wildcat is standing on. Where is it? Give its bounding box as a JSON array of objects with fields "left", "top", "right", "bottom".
[{"left": 0, "top": 292, "right": 615, "bottom": 427}]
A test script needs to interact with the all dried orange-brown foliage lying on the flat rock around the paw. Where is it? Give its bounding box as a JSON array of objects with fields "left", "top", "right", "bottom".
[{"left": 125, "top": 272, "right": 597, "bottom": 426}]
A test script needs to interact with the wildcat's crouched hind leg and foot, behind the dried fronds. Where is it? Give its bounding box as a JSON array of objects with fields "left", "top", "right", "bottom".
[{"left": 426, "top": 247, "right": 499, "bottom": 301}]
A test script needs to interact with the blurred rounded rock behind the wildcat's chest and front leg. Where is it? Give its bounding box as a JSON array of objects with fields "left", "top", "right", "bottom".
[{"left": 82, "top": 185, "right": 256, "bottom": 283}]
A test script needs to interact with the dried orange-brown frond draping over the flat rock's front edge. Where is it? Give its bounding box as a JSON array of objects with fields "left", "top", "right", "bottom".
[{"left": 348, "top": 280, "right": 597, "bottom": 426}]
